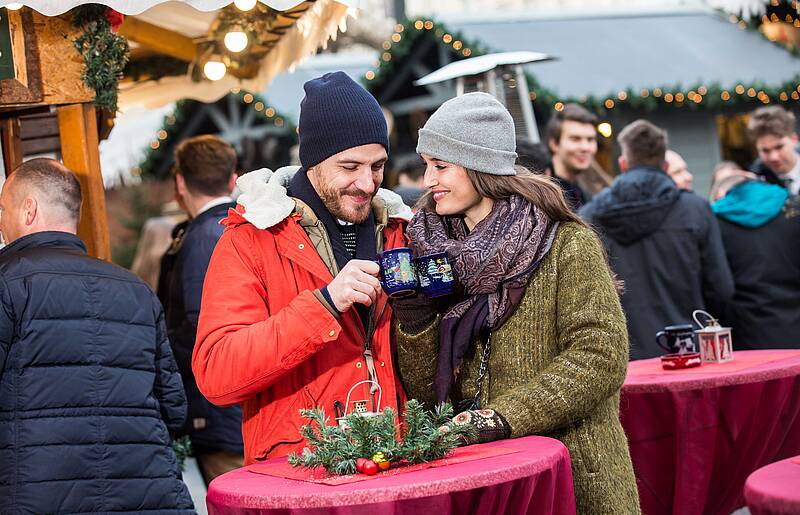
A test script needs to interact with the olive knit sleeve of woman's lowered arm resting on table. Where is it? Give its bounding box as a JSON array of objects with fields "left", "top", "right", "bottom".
[{"left": 486, "top": 229, "right": 628, "bottom": 438}]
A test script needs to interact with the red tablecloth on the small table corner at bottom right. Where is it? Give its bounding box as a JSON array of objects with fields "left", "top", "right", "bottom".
[{"left": 744, "top": 456, "right": 800, "bottom": 515}]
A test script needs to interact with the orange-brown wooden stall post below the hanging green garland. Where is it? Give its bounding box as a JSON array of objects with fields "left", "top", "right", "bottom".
[{"left": 58, "top": 103, "right": 111, "bottom": 260}]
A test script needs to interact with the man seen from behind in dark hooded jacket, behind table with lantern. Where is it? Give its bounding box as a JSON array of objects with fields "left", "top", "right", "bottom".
[{"left": 580, "top": 120, "right": 733, "bottom": 359}]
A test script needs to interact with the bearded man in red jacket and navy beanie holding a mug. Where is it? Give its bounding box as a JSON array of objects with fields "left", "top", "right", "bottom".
[{"left": 192, "top": 72, "right": 412, "bottom": 464}]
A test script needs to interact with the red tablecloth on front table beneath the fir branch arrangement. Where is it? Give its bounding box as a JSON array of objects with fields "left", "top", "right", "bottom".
[{"left": 206, "top": 436, "right": 575, "bottom": 515}]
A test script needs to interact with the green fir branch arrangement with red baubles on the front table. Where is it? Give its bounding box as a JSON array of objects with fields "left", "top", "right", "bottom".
[{"left": 289, "top": 399, "right": 474, "bottom": 475}]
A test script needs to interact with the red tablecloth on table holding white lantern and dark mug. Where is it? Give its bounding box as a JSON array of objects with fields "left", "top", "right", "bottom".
[{"left": 620, "top": 350, "right": 800, "bottom": 515}]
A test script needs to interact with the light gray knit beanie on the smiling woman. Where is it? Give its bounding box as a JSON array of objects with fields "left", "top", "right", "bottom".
[{"left": 417, "top": 93, "right": 517, "bottom": 175}]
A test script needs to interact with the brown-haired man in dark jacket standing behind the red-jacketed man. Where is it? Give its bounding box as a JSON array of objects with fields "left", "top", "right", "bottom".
[{"left": 158, "top": 135, "right": 244, "bottom": 486}]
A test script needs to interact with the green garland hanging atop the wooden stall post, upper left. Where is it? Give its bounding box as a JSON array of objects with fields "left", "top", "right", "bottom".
[{"left": 72, "top": 4, "right": 129, "bottom": 113}]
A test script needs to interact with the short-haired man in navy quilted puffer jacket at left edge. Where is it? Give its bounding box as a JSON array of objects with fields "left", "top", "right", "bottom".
[{"left": 0, "top": 159, "right": 194, "bottom": 513}]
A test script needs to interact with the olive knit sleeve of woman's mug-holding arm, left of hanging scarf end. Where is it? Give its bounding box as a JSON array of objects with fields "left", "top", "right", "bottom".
[{"left": 395, "top": 316, "right": 441, "bottom": 409}]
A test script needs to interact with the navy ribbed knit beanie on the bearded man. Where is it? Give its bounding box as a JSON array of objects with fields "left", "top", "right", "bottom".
[{"left": 299, "top": 72, "right": 389, "bottom": 170}]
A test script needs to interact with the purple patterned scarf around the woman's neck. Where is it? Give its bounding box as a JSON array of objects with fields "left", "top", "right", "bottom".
[{"left": 407, "top": 195, "right": 558, "bottom": 402}]
